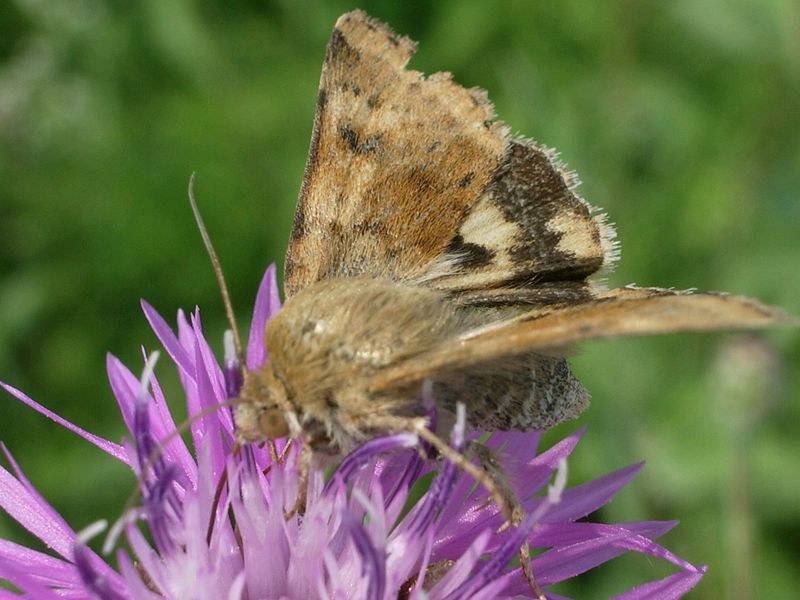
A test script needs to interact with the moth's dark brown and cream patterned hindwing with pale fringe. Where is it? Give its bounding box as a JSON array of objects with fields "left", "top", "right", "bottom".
[{"left": 424, "top": 138, "right": 618, "bottom": 305}]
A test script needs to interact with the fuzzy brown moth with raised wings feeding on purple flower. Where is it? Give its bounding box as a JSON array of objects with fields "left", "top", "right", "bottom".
[{"left": 236, "top": 11, "right": 787, "bottom": 454}]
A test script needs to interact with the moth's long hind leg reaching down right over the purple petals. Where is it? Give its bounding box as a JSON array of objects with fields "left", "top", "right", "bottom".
[{"left": 414, "top": 419, "right": 545, "bottom": 600}]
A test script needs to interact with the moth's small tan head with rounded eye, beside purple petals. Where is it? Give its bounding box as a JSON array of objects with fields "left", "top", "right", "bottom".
[{"left": 235, "top": 365, "right": 290, "bottom": 442}]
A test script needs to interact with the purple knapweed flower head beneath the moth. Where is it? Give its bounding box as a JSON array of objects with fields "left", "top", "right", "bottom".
[{"left": 0, "top": 267, "right": 704, "bottom": 600}]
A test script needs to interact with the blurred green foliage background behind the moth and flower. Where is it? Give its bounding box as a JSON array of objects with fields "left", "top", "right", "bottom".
[{"left": 0, "top": 0, "right": 800, "bottom": 598}]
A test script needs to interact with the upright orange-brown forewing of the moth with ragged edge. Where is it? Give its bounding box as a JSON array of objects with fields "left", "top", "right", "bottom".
[{"left": 285, "top": 11, "right": 505, "bottom": 295}]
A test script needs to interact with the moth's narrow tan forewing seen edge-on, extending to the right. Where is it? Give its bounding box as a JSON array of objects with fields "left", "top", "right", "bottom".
[{"left": 372, "top": 287, "right": 793, "bottom": 422}]
